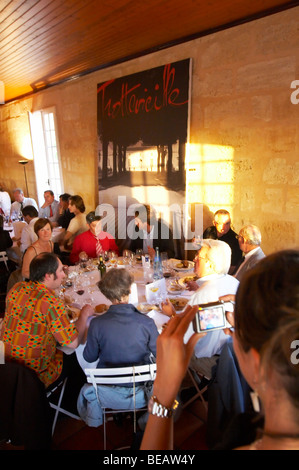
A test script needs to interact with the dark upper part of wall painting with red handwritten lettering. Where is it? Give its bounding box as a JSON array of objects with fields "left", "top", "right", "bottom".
[{"left": 97, "top": 59, "right": 191, "bottom": 191}]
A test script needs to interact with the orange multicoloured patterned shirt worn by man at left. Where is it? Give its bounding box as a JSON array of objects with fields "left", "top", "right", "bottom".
[{"left": 0, "top": 281, "right": 78, "bottom": 387}]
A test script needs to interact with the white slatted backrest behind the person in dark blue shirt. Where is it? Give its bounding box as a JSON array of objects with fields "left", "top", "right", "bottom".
[{"left": 85, "top": 364, "right": 157, "bottom": 388}]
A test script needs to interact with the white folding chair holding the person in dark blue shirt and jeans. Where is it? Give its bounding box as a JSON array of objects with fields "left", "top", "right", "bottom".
[{"left": 85, "top": 364, "right": 157, "bottom": 450}]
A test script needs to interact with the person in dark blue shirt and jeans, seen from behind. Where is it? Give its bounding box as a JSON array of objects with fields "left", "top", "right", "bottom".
[{"left": 78, "top": 268, "right": 159, "bottom": 427}]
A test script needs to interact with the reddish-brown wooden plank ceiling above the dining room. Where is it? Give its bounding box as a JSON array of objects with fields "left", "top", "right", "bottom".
[{"left": 0, "top": 0, "right": 298, "bottom": 102}]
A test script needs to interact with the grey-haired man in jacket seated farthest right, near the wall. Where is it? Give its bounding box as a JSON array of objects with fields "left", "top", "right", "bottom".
[{"left": 234, "top": 225, "right": 266, "bottom": 281}]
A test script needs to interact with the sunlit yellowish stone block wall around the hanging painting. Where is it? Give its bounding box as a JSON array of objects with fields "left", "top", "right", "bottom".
[{"left": 0, "top": 7, "right": 299, "bottom": 254}]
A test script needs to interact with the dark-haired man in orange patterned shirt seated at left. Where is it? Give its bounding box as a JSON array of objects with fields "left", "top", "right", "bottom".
[{"left": 0, "top": 253, "right": 94, "bottom": 387}]
